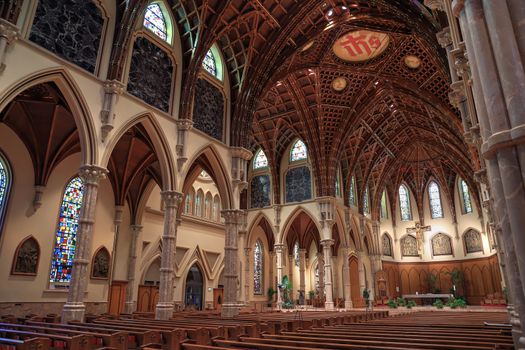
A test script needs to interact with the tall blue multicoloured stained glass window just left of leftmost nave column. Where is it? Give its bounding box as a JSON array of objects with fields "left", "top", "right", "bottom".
[{"left": 49, "top": 177, "right": 84, "bottom": 283}]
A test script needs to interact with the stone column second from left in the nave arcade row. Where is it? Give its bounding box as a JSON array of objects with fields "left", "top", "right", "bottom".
[{"left": 155, "top": 191, "right": 184, "bottom": 320}]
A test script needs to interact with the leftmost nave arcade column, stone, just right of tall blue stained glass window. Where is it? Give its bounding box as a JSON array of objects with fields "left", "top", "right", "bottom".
[{"left": 62, "top": 165, "right": 107, "bottom": 323}]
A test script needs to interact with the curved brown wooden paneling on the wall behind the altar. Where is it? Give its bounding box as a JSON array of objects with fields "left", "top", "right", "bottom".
[{"left": 383, "top": 255, "right": 502, "bottom": 305}]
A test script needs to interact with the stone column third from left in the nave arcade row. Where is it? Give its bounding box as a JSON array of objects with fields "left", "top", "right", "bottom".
[{"left": 221, "top": 209, "right": 244, "bottom": 317}]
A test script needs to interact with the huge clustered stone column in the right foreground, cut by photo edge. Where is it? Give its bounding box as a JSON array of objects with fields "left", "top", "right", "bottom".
[{"left": 454, "top": 0, "right": 525, "bottom": 347}]
